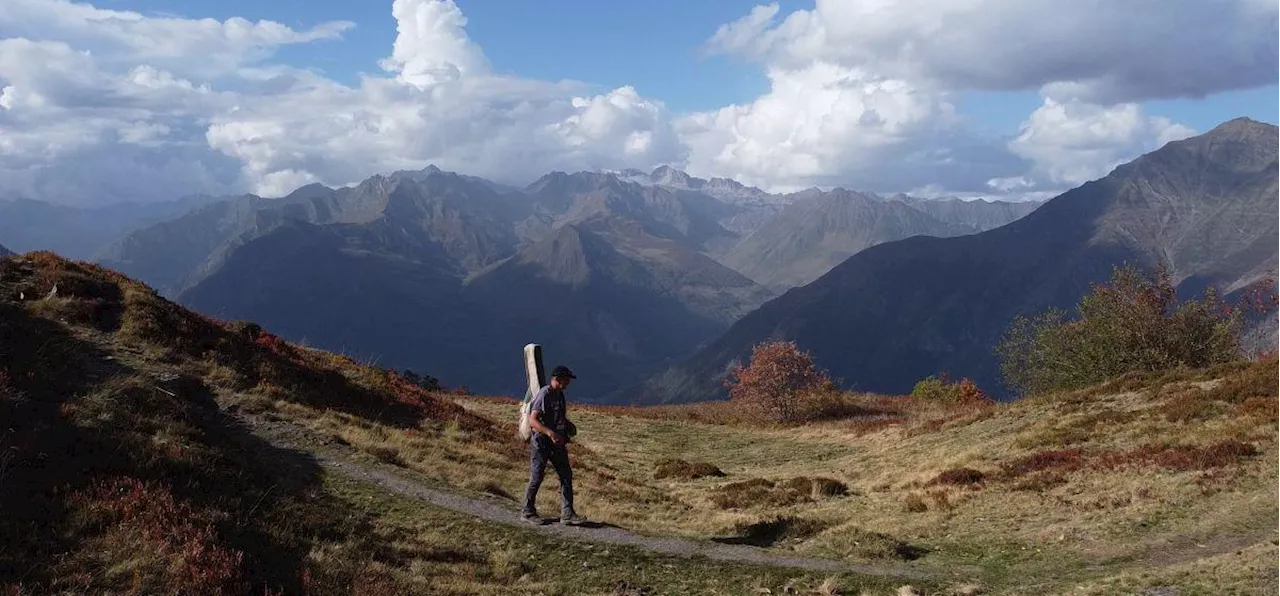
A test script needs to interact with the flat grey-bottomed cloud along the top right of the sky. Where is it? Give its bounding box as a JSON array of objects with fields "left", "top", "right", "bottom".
[{"left": 710, "top": 0, "right": 1280, "bottom": 104}]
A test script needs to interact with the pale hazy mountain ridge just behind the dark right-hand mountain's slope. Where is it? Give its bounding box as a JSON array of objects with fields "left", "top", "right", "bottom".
[{"left": 721, "top": 189, "right": 978, "bottom": 290}]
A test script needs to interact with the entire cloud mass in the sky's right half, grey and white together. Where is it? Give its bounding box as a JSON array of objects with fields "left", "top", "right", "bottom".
[{"left": 685, "top": 0, "right": 1280, "bottom": 196}]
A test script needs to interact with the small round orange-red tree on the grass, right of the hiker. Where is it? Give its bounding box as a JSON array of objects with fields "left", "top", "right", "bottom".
[{"left": 724, "top": 341, "right": 835, "bottom": 422}]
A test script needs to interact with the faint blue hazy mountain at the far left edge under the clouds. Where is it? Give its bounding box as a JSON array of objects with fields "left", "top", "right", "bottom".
[{"left": 0, "top": 196, "right": 218, "bottom": 260}]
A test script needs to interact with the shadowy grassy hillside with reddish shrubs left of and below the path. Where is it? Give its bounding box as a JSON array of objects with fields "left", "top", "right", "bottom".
[{"left": 0, "top": 253, "right": 921, "bottom": 595}]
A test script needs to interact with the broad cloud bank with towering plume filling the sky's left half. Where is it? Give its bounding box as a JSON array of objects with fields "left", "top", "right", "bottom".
[{"left": 0, "top": 0, "right": 684, "bottom": 202}]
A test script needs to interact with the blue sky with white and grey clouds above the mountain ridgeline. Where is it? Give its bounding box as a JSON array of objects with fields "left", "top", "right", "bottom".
[{"left": 0, "top": 0, "right": 1280, "bottom": 205}]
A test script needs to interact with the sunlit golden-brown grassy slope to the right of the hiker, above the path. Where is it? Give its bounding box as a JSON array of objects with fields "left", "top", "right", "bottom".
[{"left": 465, "top": 370, "right": 1280, "bottom": 593}]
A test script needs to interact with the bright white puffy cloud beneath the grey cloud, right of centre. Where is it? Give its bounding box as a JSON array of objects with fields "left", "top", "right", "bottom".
[{"left": 681, "top": 61, "right": 957, "bottom": 191}]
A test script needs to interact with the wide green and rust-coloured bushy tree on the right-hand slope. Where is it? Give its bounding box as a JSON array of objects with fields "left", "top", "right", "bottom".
[{"left": 996, "top": 266, "right": 1243, "bottom": 395}]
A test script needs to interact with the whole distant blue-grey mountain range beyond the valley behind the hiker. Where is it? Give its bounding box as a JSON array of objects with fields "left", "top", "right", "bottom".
[{"left": 0, "top": 166, "right": 1018, "bottom": 399}]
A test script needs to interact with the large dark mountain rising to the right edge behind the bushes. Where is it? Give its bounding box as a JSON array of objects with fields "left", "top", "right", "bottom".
[{"left": 640, "top": 119, "right": 1280, "bottom": 400}]
